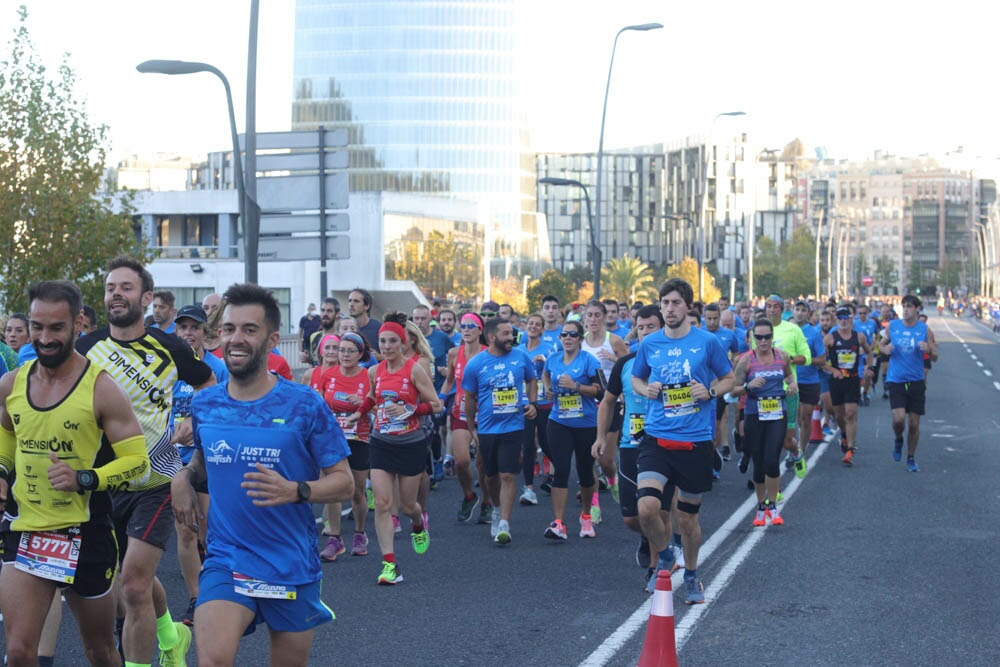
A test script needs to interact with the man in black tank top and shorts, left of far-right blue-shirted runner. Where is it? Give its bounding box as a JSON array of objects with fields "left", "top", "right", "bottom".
[{"left": 823, "top": 304, "right": 872, "bottom": 466}]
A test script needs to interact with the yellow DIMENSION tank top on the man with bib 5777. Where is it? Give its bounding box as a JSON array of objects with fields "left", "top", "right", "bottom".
[{"left": 7, "top": 361, "right": 114, "bottom": 531}]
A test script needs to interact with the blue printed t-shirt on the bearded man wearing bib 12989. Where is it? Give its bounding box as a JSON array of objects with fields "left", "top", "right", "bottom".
[{"left": 455, "top": 348, "right": 535, "bottom": 434}]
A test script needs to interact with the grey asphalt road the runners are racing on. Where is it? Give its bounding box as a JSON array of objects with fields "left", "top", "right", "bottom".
[{"left": 5, "top": 315, "right": 1000, "bottom": 666}]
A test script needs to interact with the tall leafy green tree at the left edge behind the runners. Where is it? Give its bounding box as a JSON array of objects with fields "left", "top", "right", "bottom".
[{"left": 0, "top": 7, "right": 152, "bottom": 311}]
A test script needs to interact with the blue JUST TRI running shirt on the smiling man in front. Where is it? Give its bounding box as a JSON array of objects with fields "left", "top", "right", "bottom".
[{"left": 191, "top": 378, "right": 351, "bottom": 586}]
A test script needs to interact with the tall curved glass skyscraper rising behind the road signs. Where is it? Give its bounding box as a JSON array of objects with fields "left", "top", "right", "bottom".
[{"left": 292, "top": 0, "right": 548, "bottom": 275}]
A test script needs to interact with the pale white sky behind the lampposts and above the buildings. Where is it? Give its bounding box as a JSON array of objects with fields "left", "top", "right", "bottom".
[{"left": 7, "top": 0, "right": 1000, "bottom": 167}]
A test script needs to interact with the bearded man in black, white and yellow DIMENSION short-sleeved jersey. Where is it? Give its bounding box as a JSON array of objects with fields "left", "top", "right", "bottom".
[{"left": 76, "top": 257, "right": 215, "bottom": 665}]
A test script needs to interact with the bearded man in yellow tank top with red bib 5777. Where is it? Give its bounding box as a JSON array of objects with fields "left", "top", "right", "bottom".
[{"left": 0, "top": 281, "right": 149, "bottom": 665}]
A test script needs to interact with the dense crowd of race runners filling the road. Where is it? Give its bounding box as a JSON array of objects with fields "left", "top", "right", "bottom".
[{"left": 0, "top": 257, "right": 937, "bottom": 666}]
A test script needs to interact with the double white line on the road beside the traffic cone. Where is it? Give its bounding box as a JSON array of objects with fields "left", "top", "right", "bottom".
[{"left": 580, "top": 436, "right": 832, "bottom": 667}]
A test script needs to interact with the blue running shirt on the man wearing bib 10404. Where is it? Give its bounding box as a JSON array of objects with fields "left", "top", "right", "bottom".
[{"left": 632, "top": 327, "right": 732, "bottom": 442}]
